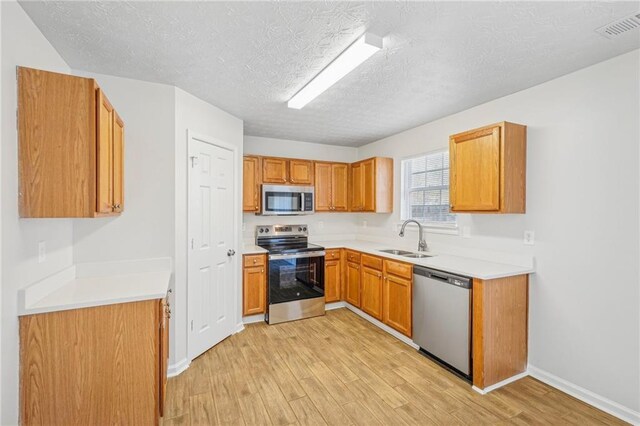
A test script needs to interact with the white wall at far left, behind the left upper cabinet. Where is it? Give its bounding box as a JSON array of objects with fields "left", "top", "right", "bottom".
[{"left": 0, "top": 1, "right": 73, "bottom": 424}]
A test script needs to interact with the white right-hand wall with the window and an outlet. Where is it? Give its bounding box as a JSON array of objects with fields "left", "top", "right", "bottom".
[{"left": 358, "top": 51, "right": 640, "bottom": 412}]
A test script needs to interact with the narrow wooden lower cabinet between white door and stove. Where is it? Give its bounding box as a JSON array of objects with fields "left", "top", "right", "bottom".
[{"left": 242, "top": 254, "right": 267, "bottom": 316}]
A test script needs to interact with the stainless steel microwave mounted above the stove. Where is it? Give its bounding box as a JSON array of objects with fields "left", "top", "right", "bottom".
[{"left": 261, "top": 185, "right": 315, "bottom": 216}]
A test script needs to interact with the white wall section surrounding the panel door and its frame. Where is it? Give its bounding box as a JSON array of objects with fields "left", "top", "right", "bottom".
[{"left": 170, "top": 88, "right": 243, "bottom": 370}]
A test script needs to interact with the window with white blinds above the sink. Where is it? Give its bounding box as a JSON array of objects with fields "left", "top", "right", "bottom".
[{"left": 402, "top": 150, "right": 456, "bottom": 227}]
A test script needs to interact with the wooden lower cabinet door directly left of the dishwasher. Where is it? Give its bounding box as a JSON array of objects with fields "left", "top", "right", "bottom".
[{"left": 382, "top": 272, "right": 411, "bottom": 337}]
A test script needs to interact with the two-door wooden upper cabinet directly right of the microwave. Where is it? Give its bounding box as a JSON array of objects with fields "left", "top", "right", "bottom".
[{"left": 315, "top": 161, "right": 349, "bottom": 211}]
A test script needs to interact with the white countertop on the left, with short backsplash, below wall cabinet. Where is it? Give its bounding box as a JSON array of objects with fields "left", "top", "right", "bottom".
[{"left": 18, "top": 259, "right": 171, "bottom": 315}]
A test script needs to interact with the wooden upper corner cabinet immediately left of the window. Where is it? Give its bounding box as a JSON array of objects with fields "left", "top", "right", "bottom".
[{"left": 350, "top": 157, "right": 393, "bottom": 213}]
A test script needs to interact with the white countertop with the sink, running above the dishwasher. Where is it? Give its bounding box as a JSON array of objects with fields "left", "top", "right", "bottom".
[{"left": 317, "top": 240, "right": 535, "bottom": 280}]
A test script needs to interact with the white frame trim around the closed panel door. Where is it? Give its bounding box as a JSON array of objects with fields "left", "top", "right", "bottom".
[{"left": 184, "top": 129, "right": 242, "bottom": 362}]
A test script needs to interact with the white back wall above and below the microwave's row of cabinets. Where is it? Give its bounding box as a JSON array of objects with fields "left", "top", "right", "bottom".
[{"left": 242, "top": 136, "right": 360, "bottom": 244}]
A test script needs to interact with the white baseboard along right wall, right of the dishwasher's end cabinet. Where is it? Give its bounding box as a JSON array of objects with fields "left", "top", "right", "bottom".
[{"left": 528, "top": 365, "right": 640, "bottom": 425}]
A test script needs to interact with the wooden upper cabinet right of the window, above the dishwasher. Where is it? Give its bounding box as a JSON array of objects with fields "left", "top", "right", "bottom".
[{"left": 449, "top": 122, "right": 527, "bottom": 213}]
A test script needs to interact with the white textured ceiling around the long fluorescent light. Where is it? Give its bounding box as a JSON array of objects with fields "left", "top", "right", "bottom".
[{"left": 21, "top": 1, "right": 640, "bottom": 146}]
